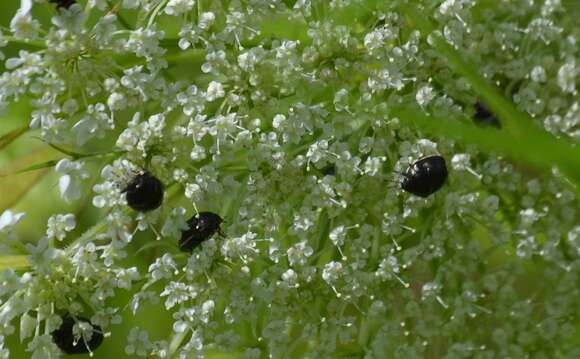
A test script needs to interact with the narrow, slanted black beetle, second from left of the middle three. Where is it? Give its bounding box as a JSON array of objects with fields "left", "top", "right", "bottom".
[{"left": 179, "top": 212, "right": 224, "bottom": 252}]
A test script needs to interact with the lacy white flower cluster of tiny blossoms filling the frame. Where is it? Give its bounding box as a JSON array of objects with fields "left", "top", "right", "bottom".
[{"left": 0, "top": 0, "right": 580, "bottom": 359}]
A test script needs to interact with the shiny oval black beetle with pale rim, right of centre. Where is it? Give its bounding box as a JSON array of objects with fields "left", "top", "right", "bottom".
[{"left": 401, "top": 155, "right": 447, "bottom": 197}]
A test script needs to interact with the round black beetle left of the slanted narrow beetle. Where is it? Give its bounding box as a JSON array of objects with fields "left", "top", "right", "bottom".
[{"left": 122, "top": 172, "right": 163, "bottom": 212}]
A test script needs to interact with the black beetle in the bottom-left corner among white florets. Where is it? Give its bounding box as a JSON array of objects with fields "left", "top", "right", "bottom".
[{"left": 51, "top": 314, "right": 104, "bottom": 354}]
